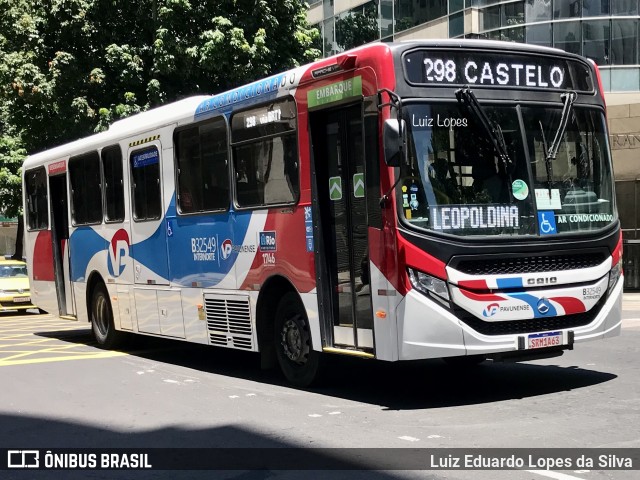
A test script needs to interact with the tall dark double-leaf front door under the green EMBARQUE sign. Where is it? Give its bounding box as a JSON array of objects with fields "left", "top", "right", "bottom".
[{"left": 309, "top": 103, "right": 374, "bottom": 351}]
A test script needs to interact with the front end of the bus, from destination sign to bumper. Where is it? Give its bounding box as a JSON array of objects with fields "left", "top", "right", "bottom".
[{"left": 382, "top": 41, "right": 623, "bottom": 363}]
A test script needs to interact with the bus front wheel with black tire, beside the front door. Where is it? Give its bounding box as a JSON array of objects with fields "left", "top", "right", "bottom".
[{"left": 274, "top": 292, "right": 320, "bottom": 388}]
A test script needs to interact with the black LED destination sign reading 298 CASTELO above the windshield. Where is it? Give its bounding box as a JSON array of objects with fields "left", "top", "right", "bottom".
[{"left": 404, "top": 50, "right": 594, "bottom": 92}]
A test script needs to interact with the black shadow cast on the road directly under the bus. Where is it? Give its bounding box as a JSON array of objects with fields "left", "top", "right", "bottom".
[{"left": 36, "top": 330, "right": 616, "bottom": 410}]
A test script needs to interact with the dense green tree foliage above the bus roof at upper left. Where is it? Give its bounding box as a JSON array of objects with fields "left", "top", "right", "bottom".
[{"left": 0, "top": 0, "right": 320, "bottom": 224}]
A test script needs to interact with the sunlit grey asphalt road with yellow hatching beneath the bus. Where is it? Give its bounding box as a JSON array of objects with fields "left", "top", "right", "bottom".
[{"left": 0, "top": 294, "right": 640, "bottom": 480}]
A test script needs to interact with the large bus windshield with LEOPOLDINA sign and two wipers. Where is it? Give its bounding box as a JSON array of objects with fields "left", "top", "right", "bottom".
[{"left": 397, "top": 101, "right": 617, "bottom": 236}]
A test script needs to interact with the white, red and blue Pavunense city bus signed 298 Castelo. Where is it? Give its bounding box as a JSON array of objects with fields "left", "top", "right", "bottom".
[{"left": 23, "top": 40, "right": 623, "bottom": 386}]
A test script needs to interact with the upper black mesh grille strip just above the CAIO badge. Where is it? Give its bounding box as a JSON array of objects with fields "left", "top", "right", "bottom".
[{"left": 451, "top": 251, "right": 607, "bottom": 275}]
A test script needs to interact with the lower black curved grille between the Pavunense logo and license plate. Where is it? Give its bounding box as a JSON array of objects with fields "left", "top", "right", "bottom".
[{"left": 455, "top": 297, "right": 606, "bottom": 335}]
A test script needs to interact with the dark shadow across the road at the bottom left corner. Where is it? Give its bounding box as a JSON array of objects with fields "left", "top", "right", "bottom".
[{"left": 0, "top": 414, "right": 438, "bottom": 480}]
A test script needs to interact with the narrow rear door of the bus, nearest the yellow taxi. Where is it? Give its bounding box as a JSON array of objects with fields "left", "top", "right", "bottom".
[{"left": 49, "top": 173, "right": 76, "bottom": 316}]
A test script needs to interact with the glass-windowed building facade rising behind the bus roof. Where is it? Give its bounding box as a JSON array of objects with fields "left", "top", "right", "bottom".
[{"left": 308, "top": 0, "right": 640, "bottom": 92}]
